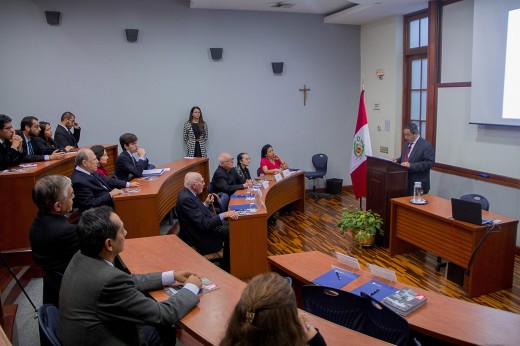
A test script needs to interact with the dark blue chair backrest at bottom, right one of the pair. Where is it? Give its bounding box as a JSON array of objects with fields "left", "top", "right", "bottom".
[{"left": 361, "top": 292, "right": 410, "bottom": 345}]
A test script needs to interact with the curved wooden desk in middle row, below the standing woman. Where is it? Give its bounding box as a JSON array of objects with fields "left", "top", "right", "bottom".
[{"left": 114, "top": 158, "right": 210, "bottom": 238}]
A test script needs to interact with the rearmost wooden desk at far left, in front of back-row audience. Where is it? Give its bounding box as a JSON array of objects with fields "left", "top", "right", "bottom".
[{"left": 0, "top": 144, "right": 117, "bottom": 250}]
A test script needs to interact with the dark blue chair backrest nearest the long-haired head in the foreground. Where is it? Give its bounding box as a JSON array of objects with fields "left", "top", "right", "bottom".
[{"left": 302, "top": 285, "right": 366, "bottom": 331}]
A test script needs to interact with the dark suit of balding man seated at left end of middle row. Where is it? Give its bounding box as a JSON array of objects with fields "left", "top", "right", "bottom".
[{"left": 71, "top": 169, "right": 126, "bottom": 211}]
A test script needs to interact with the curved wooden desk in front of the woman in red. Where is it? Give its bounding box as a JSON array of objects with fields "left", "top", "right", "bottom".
[{"left": 229, "top": 171, "right": 305, "bottom": 279}]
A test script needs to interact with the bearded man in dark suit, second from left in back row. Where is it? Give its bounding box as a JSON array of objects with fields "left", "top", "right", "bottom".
[{"left": 18, "top": 115, "right": 65, "bottom": 162}]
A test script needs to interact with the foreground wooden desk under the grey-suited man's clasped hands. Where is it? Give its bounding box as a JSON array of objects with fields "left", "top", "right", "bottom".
[{"left": 119, "top": 235, "right": 388, "bottom": 346}]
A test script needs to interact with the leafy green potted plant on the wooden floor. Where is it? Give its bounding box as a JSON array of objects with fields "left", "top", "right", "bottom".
[{"left": 338, "top": 205, "right": 383, "bottom": 246}]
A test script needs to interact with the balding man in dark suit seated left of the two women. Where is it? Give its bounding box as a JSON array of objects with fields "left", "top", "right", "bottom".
[{"left": 211, "top": 153, "right": 253, "bottom": 196}]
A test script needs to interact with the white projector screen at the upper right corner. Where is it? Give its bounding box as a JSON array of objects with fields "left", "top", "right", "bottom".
[{"left": 470, "top": 0, "right": 520, "bottom": 126}]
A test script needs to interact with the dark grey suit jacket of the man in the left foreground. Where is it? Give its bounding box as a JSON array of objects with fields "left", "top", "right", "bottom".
[{"left": 58, "top": 252, "right": 199, "bottom": 346}]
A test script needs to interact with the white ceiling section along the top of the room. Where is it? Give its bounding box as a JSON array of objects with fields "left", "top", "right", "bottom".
[{"left": 190, "top": 0, "right": 428, "bottom": 25}]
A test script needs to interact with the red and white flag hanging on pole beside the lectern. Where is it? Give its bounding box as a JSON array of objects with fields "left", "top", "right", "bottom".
[{"left": 350, "top": 90, "right": 372, "bottom": 199}]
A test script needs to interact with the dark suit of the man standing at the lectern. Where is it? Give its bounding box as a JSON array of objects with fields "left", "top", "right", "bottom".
[{"left": 397, "top": 137, "right": 435, "bottom": 196}]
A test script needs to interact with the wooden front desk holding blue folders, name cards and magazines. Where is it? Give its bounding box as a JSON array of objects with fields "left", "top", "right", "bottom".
[{"left": 269, "top": 251, "right": 520, "bottom": 345}]
